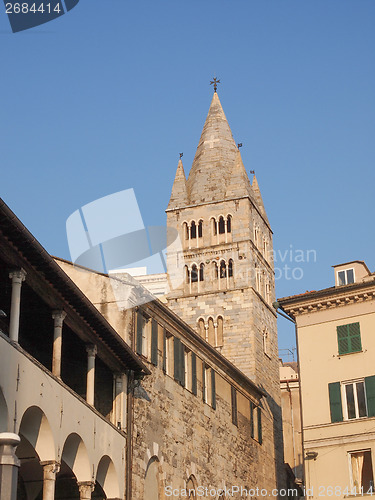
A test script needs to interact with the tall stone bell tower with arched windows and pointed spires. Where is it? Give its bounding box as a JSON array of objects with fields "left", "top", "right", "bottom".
[{"left": 166, "top": 89, "right": 283, "bottom": 486}]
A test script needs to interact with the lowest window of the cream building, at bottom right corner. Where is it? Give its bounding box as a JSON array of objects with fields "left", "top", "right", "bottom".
[{"left": 349, "top": 450, "right": 374, "bottom": 495}]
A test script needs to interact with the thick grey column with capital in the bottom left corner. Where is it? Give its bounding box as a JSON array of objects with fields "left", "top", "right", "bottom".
[{"left": 0, "top": 432, "right": 21, "bottom": 500}]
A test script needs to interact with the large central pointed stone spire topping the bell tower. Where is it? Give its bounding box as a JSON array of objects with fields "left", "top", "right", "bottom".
[{"left": 187, "top": 92, "right": 238, "bottom": 205}]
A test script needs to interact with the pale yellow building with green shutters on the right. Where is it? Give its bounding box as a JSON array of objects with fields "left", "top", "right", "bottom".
[{"left": 278, "top": 261, "right": 375, "bottom": 498}]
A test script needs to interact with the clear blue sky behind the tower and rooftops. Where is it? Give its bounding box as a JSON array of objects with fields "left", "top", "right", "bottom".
[{"left": 0, "top": 0, "right": 375, "bottom": 358}]
